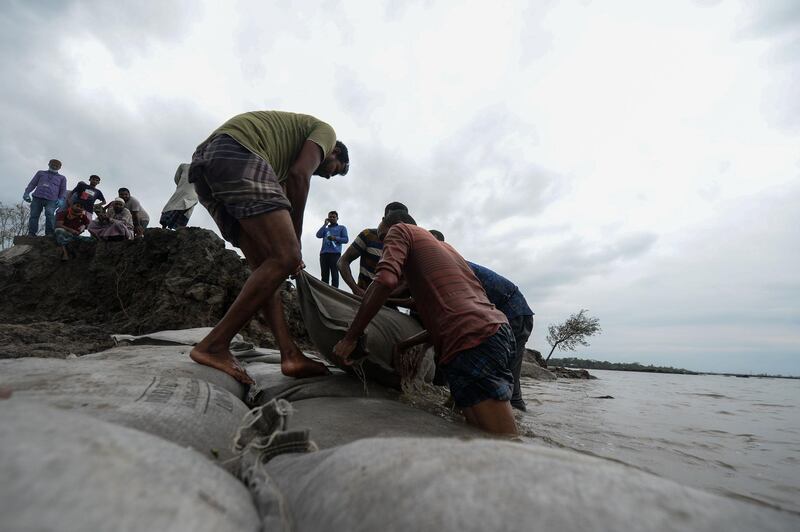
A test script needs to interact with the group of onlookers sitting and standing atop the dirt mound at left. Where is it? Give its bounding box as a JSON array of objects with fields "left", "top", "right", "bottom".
[{"left": 22, "top": 159, "right": 197, "bottom": 260}]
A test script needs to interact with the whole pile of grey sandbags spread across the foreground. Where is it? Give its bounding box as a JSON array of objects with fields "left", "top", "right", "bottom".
[{"left": 0, "top": 331, "right": 800, "bottom": 531}]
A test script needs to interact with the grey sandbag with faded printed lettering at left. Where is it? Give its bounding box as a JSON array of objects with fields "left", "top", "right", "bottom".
[{"left": 0, "top": 358, "right": 248, "bottom": 461}]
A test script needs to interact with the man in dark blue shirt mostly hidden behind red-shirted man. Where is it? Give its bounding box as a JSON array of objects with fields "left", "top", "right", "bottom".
[{"left": 431, "top": 229, "right": 534, "bottom": 412}]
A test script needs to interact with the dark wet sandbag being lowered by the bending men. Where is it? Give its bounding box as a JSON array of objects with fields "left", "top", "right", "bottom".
[{"left": 296, "top": 271, "right": 434, "bottom": 388}]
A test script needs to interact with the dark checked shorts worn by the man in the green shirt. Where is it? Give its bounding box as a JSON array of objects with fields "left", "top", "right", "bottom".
[{"left": 189, "top": 135, "right": 292, "bottom": 246}]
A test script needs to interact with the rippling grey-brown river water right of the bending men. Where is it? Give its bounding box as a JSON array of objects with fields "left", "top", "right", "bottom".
[{"left": 518, "top": 370, "right": 800, "bottom": 513}]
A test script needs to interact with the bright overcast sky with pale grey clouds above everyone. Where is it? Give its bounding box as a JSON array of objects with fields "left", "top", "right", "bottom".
[{"left": 0, "top": 0, "right": 800, "bottom": 375}]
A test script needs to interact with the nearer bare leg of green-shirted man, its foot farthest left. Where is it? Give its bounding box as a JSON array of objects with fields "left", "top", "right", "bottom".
[{"left": 190, "top": 209, "right": 301, "bottom": 384}]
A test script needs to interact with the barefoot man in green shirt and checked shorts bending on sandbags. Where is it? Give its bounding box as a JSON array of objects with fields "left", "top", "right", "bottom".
[{"left": 189, "top": 111, "right": 350, "bottom": 384}]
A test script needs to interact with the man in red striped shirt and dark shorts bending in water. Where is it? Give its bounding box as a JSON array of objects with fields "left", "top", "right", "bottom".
[{"left": 334, "top": 212, "right": 517, "bottom": 434}]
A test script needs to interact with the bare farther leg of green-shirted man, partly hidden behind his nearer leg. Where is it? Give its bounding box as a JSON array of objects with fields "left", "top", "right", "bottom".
[{"left": 239, "top": 233, "right": 330, "bottom": 378}]
